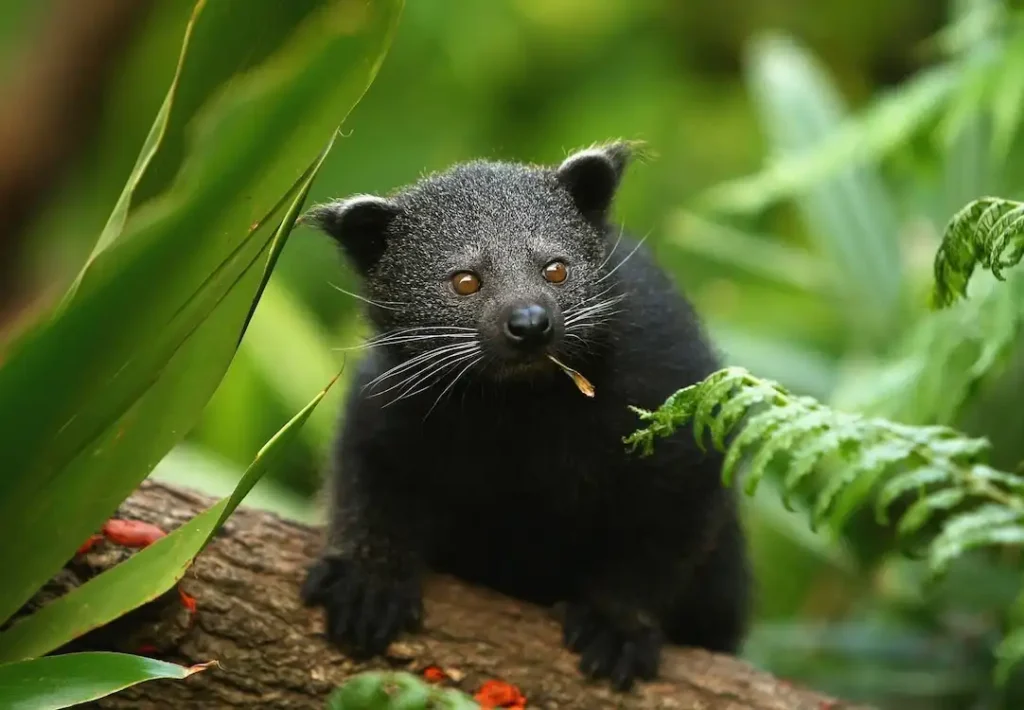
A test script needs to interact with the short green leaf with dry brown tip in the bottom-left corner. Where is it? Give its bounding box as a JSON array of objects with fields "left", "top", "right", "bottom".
[{"left": 0, "top": 653, "right": 211, "bottom": 710}]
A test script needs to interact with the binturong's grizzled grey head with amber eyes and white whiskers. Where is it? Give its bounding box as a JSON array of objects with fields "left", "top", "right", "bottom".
[{"left": 306, "top": 142, "right": 631, "bottom": 387}]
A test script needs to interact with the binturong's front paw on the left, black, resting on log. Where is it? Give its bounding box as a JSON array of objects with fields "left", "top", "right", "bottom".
[{"left": 301, "top": 557, "right": 423, "bottom": 659}]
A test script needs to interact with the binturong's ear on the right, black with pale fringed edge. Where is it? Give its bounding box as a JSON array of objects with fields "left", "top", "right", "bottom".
[{"left": 555, "top": 141, "right": 633, "bottom": 220}]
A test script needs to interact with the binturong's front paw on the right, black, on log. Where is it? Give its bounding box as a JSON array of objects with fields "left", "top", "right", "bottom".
[{"left": 563, "top": 603, "right": 662, "bottom": 691}]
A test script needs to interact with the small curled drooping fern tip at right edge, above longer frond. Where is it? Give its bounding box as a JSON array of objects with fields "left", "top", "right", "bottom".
[{"left": 933, "top": 197, "right": 1024, "bottom": 308}]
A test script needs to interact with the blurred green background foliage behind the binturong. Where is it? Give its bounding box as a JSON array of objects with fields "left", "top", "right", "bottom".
[{"left": 0, "top": 0, "right": 1024, "bottom": 710}]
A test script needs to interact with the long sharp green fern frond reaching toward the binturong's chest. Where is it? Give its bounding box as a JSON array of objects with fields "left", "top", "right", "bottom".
[{"left": 626, "top": 368, "right": 1024, "bottom": 680}]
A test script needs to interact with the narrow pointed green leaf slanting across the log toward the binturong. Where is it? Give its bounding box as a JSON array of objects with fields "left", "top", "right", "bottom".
[{"left": 0, "top": 368, "right": 338, "bottom": 662}]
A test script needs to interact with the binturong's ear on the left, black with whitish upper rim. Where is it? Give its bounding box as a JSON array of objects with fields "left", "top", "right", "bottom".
[{"left": 302, "top": 195, "right": 401, "bottom": 273}]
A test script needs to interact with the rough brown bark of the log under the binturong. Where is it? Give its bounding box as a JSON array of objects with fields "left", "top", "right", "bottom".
[{"left": 33, "top": 483, "right": 868, "bottom": 710}]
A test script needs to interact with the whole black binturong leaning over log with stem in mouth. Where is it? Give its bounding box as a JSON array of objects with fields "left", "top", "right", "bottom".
[{"left": 302, "top": 141, "right": 750, "bottom": 691}]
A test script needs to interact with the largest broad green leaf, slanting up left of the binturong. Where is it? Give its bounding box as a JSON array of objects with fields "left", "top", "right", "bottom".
[{"left": 0, "top": 0, "right": 401, "bottom": 619}]
